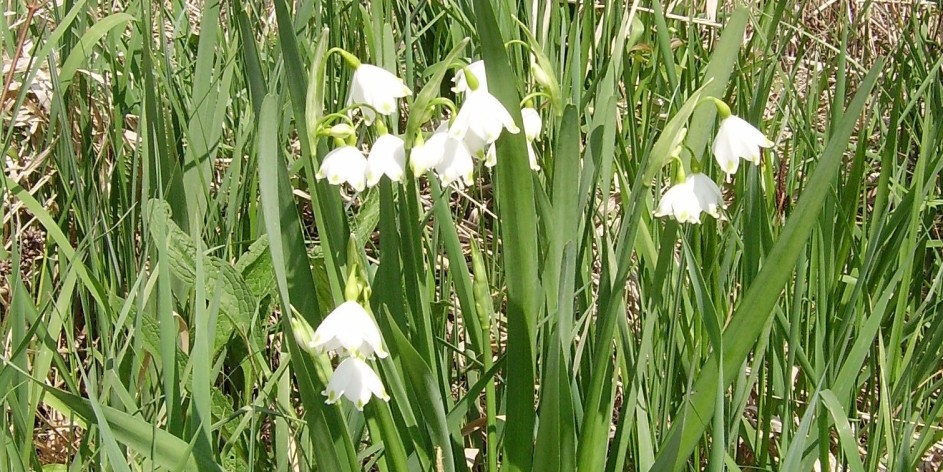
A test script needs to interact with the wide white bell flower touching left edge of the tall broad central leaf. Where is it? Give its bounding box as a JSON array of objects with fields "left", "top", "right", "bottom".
[{"left": 449, "top": 89, "right": 520, "bottom": 144}]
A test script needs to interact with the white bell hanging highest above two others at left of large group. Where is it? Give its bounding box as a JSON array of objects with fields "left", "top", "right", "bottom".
[{"left": 347, "top": 64, "right": 413, "bottom": 125}]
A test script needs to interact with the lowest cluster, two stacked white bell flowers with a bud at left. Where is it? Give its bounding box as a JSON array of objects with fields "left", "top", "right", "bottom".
[{"left": 292, "top": 300, "right": 390, "bottom": 410}]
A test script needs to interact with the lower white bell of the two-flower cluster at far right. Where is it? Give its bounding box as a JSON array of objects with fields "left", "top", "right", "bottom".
[{"left": 654, "top": 173, "right": 724, "bottom": 223}]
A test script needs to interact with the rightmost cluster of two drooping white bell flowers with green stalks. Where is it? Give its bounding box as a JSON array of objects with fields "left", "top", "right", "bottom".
[{"left": 654, "top": 103, "right": 773, "bottom": 223}]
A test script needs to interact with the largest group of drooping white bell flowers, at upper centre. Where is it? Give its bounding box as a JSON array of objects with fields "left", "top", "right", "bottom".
[{"left": 316, "top": 54, "right": 543, "bottom": 192}]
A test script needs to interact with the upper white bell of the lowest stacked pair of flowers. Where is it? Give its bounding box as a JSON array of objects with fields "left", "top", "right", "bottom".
[{"left": 307, "top": 301, "right": 388, "bottom": 359}]
